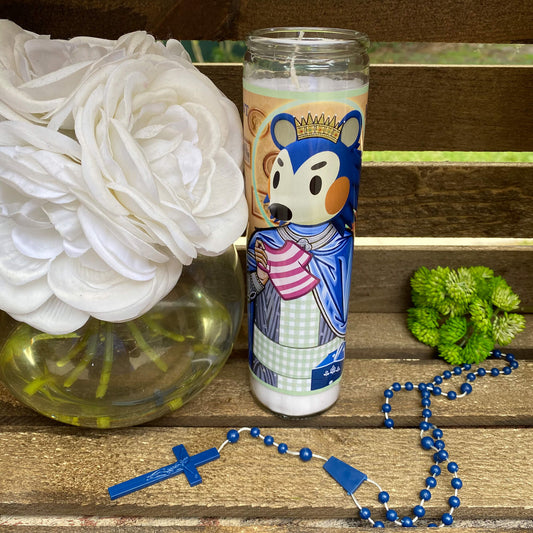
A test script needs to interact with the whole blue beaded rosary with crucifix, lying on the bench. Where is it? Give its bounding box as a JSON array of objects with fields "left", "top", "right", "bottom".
[{"left": 108, "top": 350, "right": 518, "bottom": 528}]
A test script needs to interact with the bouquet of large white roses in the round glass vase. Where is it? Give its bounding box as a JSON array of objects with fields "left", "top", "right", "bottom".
[{"left": 0, "top": 20, "right": 247, "bottom": 334}]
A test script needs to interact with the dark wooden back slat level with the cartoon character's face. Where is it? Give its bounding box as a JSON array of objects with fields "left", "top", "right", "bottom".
[{"left": 357, "top": 162, "right": 533, "bottom": 238}]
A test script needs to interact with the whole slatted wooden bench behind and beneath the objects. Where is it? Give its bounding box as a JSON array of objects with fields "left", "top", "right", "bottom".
[{"left": 0, "top": 0, "right": 533, "bottom": 533}]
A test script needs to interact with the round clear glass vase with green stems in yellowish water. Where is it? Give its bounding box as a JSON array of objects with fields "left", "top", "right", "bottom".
[{"left": 0, "top": 247, "right": 244, "bottom": 428}]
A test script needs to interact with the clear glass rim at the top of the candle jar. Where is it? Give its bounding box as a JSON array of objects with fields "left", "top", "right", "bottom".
[{"left": 246, "top": 26, "right": 370, "bottom": 55}]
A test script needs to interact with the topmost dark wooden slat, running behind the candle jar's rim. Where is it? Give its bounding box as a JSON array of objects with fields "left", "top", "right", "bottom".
[{"left": 0, "top": 0, "right": 533, "bottom": 43}]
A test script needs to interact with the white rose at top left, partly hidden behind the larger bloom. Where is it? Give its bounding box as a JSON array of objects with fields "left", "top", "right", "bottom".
[{"left": 0, "top": 19, "right": 188, "bottom": 129}]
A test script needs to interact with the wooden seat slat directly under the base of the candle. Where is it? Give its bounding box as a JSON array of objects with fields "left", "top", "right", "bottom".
[{"left": 0, "top": 358, "right": 533, "bottom": 428}]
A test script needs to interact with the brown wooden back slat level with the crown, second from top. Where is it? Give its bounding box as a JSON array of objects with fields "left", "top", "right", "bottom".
[{"left": 198, "top": 63, "right": 533, "bottom": 152}]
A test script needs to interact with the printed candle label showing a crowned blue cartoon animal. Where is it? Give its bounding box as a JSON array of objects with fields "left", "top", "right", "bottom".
[{"left": 244, "top": 82, "right": 368, "bottom": 395}]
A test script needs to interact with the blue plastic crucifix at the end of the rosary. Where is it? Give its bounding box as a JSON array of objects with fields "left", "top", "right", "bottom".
[{"left": 107, "top": 444, "right": 220, "bottom": 500}]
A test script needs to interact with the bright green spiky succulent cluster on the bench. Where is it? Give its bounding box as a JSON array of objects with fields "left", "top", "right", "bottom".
[{"left": 407, "top": 266, "right": 526, "bottom": 365}]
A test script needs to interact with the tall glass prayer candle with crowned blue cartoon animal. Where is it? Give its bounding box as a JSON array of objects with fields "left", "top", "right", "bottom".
[{"left": 243, "top": 28, "right": 368, "bottom": 417}]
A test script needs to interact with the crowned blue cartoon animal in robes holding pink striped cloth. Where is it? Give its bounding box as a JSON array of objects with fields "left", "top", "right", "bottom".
[{"left": 247, "top": 110, "right": 362, "bottom": 394}]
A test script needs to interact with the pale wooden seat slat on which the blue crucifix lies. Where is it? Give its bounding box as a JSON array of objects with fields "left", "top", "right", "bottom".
[{"left": 0, "top": 427, "right": 533, "bottom": 519}]
